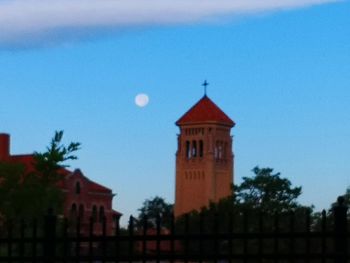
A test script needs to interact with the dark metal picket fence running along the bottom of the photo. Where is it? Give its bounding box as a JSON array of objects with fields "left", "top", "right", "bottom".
[{"left": 0, "top": 200, "right": 350, "bottom": 263}]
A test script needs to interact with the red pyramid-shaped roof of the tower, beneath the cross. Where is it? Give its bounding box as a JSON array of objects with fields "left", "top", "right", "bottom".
[{"left": 176, "top": 95, "right": 235, "bottom": 127}]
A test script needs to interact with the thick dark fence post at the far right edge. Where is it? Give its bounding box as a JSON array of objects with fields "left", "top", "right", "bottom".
[{"left": 333, "top": 196, "right": 348, "bottom": 263}]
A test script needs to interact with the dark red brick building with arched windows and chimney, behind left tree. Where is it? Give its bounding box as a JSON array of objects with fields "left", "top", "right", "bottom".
[{"left": 0, "top": 133, "right": 121, "bottom": 234}]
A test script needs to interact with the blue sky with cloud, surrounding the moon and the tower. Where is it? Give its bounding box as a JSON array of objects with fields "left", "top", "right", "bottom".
[{"left": 0, "top": 0, "right": 350, "bottom": 226}]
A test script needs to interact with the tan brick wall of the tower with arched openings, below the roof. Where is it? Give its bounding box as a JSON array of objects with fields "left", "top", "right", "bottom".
[{"left": 175, "top": 124, "right": 233, "bottom": 217}]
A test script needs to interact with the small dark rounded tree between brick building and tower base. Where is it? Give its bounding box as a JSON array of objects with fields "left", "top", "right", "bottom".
[{"left": 138, "top": 196, "right": 173, "bottom": 227}]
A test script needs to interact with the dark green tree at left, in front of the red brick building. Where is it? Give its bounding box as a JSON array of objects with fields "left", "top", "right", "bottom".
[{"left": 0, "top": 131, "right": 80, "bottom": 220}]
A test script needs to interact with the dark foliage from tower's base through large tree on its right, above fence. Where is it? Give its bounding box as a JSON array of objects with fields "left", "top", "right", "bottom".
[{"left": 177, "top": 167, "right": 313, "bottom": 235}]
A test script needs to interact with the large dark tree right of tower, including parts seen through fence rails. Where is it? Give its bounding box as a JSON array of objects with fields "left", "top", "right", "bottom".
[{"left": 176, "top": 167, "right": 312, "bottom": 254}]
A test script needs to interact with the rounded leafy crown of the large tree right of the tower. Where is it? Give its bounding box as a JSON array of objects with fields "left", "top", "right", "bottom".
[{"left": 233, "top": 166, "right": 301, "bottom": 213}]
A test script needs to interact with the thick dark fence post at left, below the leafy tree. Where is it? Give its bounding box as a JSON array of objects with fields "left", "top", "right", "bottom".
[{"left": 43, "top": 209, "right": 56, "bottom": 263}]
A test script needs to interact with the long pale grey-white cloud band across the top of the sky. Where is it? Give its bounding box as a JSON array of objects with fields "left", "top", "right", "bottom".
[{"left": 0, "top": 0, "right": 337, "bottom": 45}]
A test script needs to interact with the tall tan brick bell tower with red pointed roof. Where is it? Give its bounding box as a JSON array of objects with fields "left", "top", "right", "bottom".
[{"left": 175, "top": 95, "right": 235, "bottom": 217}]
